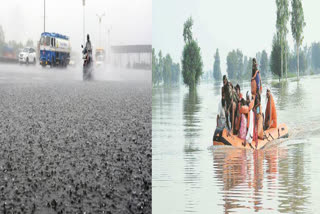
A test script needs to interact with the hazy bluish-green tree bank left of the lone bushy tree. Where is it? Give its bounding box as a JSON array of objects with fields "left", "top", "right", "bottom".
[{"left": 152, "top": 48, "right": 180, "bottom": 86}]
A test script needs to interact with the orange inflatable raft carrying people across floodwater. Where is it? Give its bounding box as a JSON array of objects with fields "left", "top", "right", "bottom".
[{"left": 213, "top": 124, "right": 289, "bottom": 149}]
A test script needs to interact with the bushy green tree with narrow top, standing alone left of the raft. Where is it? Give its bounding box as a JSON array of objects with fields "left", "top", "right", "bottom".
[{"left": 181, "top": 17, "right": 203, "bottom": 90}]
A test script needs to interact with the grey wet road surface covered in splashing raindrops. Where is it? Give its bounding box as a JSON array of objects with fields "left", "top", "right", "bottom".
[{"left": 0, "top": 64, "right": 152, "bottom": 213}]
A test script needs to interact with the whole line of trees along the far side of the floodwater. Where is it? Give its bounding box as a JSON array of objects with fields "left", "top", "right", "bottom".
[{"left": 152, "top": 0, "right": 320, "bottom": 89}]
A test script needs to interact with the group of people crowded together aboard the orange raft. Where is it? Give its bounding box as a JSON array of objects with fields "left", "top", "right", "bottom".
[{"left": 217, "top": 58, "right": 277, "bottom": 146}]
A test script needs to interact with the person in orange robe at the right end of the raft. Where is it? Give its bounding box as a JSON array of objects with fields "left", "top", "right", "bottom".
[{"left": 264, "top": 88, "right": 277, "bottom": 130}]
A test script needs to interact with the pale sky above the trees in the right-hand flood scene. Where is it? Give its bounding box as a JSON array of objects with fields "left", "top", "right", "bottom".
[{"left": 152, "top": 0, "right": 320, "bottom": 73}]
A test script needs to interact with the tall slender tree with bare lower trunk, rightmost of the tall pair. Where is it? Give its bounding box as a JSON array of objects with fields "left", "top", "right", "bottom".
[{"left": 291, "top": 0, "right": 306, "bottom": 79}]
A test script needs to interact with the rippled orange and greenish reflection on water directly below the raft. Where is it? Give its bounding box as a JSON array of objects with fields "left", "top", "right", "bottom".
[{"left": 213, "top": 141, "right": 310, "bottom": 213}]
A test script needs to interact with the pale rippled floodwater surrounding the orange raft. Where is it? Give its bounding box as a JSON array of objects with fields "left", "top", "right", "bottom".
[{"left": 152, "top": 76, "right": 320, "bottom": 213}]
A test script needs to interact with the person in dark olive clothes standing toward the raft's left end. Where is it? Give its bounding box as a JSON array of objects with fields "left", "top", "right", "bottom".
[{"left": 222, "top": 75, "right": 239, "bottom": 133}]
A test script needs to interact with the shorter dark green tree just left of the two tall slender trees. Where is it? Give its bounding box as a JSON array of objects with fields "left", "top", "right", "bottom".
[{"left": 270, "top": 35, "right": 282, "bottom": 81}]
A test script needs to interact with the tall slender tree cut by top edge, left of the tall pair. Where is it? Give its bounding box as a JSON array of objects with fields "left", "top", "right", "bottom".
[{"left": 276, "top": 0, "right": 289, "bottom": 77}]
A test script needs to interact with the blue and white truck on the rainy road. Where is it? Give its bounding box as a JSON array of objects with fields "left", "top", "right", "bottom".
[{"left": 39, "top": 32, "right": 71, "bottom": 67}]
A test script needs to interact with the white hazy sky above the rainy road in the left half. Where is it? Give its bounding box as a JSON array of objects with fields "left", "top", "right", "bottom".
[{"left": 0, "top": 0, "right": 152, "bottom": 50}]
